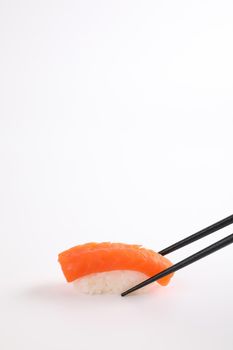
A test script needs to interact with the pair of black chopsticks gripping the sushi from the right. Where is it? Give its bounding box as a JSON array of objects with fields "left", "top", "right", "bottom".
[{"left": 121, "top": 215, "right": 233, "bottom": 297}]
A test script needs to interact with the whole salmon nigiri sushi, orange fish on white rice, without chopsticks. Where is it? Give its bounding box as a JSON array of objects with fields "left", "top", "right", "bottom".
[{"left": 58, "top": 242, "right": 172, "bottom": 294}]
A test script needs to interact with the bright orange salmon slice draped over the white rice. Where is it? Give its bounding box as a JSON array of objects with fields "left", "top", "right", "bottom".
[{"left": 58, "top": 242, "right": 173, "bottom": 286}]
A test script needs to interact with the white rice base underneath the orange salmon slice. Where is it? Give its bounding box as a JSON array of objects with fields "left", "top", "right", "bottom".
[{"left": 73, "top": 270, "right": 152, "bottom": 294}]
